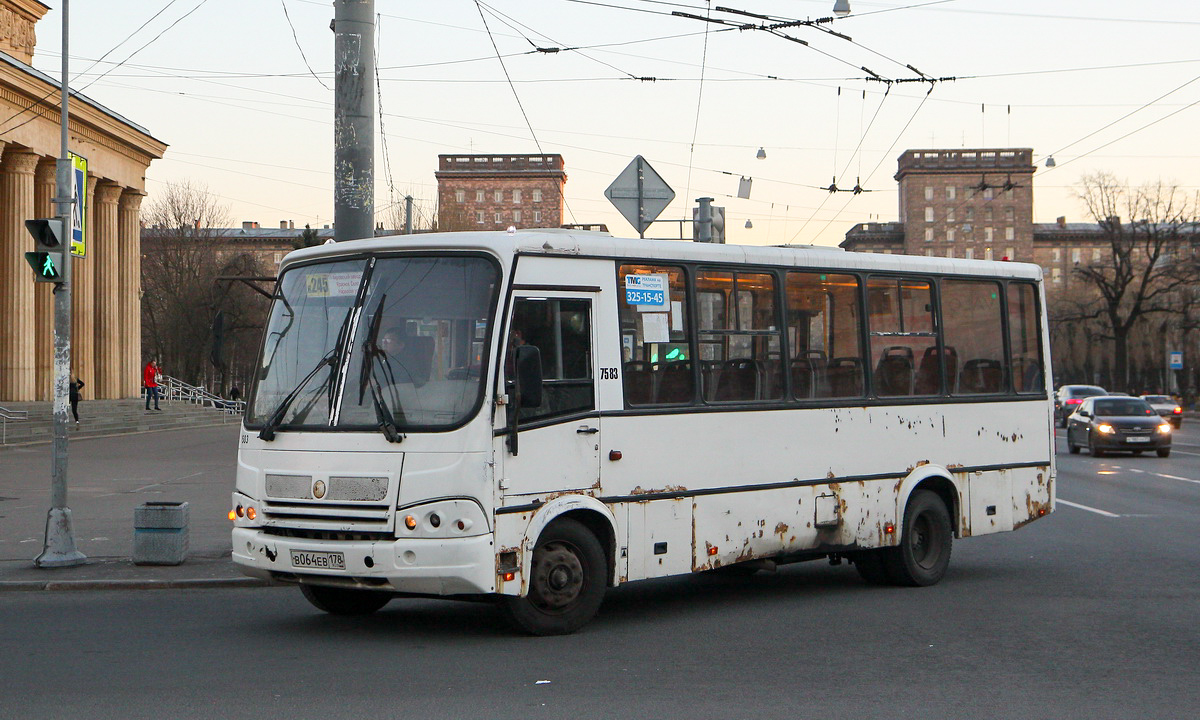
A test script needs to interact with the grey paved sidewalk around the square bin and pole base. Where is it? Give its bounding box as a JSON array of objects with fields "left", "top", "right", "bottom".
[{"left": 0, "top": 425, "right": 268, "bottom": 593}]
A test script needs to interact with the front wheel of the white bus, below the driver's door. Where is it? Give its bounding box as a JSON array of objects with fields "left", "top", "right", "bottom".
[{"left": 505, "top": 517, "right": 606, "bottom": 635}]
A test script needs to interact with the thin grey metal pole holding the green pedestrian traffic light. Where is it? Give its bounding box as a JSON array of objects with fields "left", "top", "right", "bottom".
[{"left": 34, "top": 0, "right": 88, "bottom": 568}]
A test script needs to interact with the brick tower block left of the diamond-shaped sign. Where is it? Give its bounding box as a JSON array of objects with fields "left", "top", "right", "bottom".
[{"left": 434, "top": 155, "right": 566, "bottom": 232}]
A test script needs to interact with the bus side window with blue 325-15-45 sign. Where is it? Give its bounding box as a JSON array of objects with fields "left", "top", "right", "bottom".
[{"left": 617, "top": 265, "right": 696, "bottom": 406}]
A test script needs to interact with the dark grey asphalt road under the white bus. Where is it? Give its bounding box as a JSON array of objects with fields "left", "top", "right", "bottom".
[{"left": 0, "top": 426, "right": 1200, "bottom": 720}]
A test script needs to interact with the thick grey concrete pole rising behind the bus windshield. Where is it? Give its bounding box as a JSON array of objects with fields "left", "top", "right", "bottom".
[{"left": 334, "top": 0, "right": 376, "bottom": 242}]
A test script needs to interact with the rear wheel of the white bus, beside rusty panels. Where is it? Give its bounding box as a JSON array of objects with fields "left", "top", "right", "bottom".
[{"left": 882, "top": 490, "right": 954, "bottom": 587}]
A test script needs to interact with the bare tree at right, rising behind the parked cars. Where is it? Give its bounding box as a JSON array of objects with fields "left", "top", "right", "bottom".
[{"left": 1073, "top": 173, "right": 1198, "bottom": 390}]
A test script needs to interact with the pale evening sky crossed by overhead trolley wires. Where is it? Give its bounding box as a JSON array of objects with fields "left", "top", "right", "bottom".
[{"left": 23, "top": 0, "right": 1200, "bottom": 245}]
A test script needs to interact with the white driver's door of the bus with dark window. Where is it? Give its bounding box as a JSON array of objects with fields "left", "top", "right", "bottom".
[{"left": 496, "top": 290, "right": 600, "bottom": 505}]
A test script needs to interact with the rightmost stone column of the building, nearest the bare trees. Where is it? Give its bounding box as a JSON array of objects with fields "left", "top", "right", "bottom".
[{"left": 116, "top": 187, "right": 145, "bottom": 397}]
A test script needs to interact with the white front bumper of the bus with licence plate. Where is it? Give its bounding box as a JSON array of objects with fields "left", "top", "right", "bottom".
[{"left": 233, "top": 528, "right": 496, "bottom": 595}]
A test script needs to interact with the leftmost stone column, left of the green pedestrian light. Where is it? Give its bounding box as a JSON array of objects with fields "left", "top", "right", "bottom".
[{"left": 0, "top": 148, "right": 38, "bottom": 402}]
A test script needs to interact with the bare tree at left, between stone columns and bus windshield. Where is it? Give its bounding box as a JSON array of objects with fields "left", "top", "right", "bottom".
[{"left": 142, "top": 182, "right": 266, "bottom": 392}]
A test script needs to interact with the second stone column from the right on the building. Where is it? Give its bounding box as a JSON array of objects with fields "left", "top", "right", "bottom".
[{"left": 88, "top": 180, "right": 121, "bottom": 400}]
